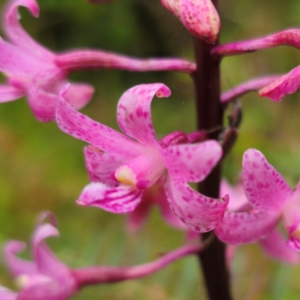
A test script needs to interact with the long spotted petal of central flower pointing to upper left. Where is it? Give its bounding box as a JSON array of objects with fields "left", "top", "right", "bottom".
[{"left": 56, "top": 97, "right": 143, "bottom": 159}]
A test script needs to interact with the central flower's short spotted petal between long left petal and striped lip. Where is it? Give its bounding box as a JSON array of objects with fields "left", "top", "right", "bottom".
[{"left": 84, "top": 146, "right": 125, "bottom": 185}]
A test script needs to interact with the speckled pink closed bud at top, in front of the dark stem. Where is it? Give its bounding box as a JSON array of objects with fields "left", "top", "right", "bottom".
[{"left": 161, "top": 0, "right": 220, "bottom": 44}]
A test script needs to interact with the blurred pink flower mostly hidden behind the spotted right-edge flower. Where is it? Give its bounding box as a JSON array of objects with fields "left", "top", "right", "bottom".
[{"left": 221, "top": 180, "right": 300, "bottom": 264}]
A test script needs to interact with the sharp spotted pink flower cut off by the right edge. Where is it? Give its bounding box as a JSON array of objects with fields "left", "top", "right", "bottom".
[{"left": 215, "top": 149, "right": 300, "bottom": 252}]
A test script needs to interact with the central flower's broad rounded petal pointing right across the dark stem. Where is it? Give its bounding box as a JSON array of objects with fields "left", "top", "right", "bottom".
[{"left": 161, "top": 141, "right": 222, "bottom": 182}]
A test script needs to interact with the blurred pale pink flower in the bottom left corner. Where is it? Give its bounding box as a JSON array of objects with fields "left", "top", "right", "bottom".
[{"left": 0, "top": 213, "right": 78, "bottom": 300}]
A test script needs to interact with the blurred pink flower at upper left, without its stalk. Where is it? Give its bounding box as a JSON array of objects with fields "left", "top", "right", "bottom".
[{"left": 0, "top": 0, "right": 94, "bottom": 122}]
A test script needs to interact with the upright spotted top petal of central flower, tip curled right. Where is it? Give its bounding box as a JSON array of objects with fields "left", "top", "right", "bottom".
[{"left": 117, "top": 83, "right": 171, "bottom": 146}]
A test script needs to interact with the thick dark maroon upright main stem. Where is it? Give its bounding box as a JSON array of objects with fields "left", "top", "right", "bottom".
[{"left": 193, "top": 0, "right": 232, "bottom": 300}]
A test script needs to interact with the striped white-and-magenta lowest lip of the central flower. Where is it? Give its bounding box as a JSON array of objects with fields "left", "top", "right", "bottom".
[{"left": 77, "top": 182, "right": 143, "bottom": 214}]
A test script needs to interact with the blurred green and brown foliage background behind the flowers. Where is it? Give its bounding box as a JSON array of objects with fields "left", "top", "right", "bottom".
[{"left": 0, "top": 0, "right": 300, "bottom": 300}]
